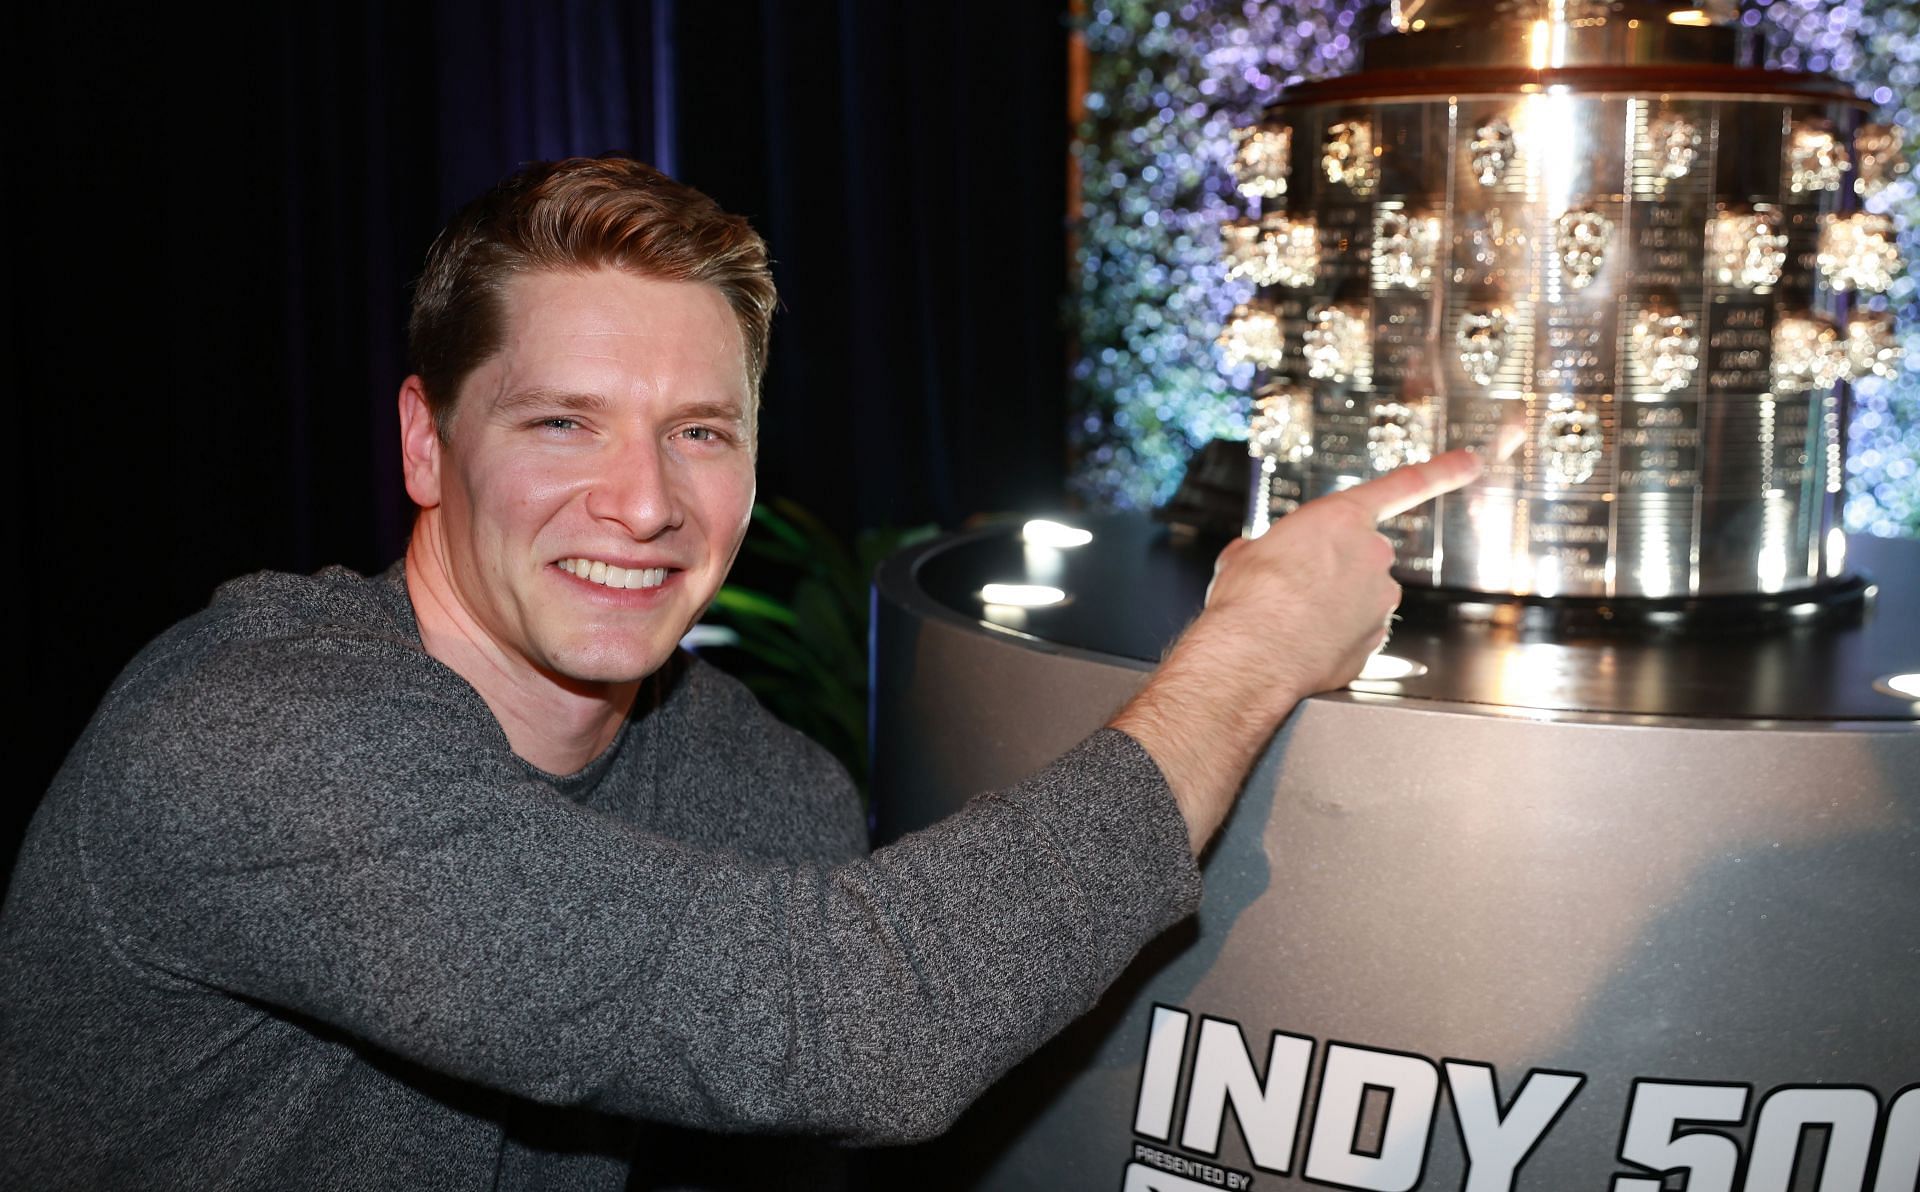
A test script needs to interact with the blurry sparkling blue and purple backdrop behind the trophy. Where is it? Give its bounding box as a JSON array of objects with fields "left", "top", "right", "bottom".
[{"left": 1069, "top": 0, "right": 1920, "bottom": 536}]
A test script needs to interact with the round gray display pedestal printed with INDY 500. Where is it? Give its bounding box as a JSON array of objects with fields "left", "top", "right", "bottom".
[{"left": 876, "top": 518, "right": 1920, "bottom": 1192}]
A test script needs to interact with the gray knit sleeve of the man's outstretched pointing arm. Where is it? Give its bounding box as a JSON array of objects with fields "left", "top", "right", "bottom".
[{"left": 83, "top": 641, "right": 1198, "bottom": 1142}]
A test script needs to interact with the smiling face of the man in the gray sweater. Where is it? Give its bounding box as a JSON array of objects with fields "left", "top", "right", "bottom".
[{"left": 409, "top": 269, "right": 753, "bottom": 683}]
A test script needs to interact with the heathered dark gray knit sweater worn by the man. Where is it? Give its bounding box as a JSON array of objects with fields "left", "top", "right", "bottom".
[{"left": 0, "top": 566, "right": 1200, "bottom": 1188}]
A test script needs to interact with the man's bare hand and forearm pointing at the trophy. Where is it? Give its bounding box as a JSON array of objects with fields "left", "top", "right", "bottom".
[{"left": 1112, "top": 443, "right": 1480, "bottom": 852}]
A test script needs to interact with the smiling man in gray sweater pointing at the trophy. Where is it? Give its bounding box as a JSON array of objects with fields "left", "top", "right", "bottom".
[{"left": 0, "top": 159, "right": 1475, "bottom": 1188}]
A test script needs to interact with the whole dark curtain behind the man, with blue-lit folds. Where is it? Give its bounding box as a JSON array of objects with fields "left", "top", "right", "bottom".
[{"left": 0, "top": 0, "right": 1066, "bottom": 868}]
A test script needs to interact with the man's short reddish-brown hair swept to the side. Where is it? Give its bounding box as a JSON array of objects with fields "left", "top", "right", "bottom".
[{"left": 407, "top": 157, "right": 776, "bottom": 438}]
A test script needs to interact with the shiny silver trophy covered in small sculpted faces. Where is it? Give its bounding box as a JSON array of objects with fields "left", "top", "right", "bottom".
[{"left": 1219, "top": 0, "right": 1907, "bottom": 603}]
